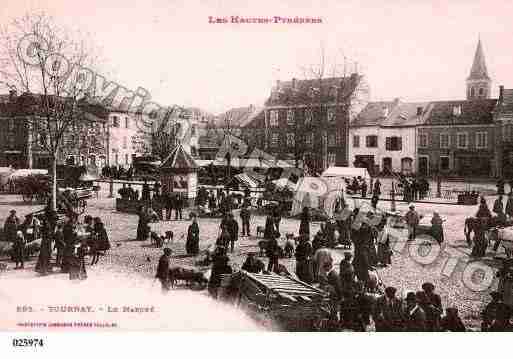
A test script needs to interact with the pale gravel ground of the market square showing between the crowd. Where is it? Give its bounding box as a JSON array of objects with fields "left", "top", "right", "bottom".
[{"left": 0, "top": 193, "right": 501, "bottom": 328}]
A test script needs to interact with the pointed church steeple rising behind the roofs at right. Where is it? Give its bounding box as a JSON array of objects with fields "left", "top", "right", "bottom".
[{"left": 467, "top": 38, "right": 492, "bottom": 100}]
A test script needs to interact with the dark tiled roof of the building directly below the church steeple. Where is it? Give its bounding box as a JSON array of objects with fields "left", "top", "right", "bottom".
[{"left": 424, "top": 99, "right": 497, "bottom": 126}]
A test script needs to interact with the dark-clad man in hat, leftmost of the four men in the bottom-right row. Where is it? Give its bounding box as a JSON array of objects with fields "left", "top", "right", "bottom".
[{"left": 374, "top": 287, "right": 404, "bottom": 332}]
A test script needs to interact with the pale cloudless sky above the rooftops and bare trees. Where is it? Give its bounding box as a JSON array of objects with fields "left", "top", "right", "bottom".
[{"left": 0, "top": 0, "right": 513, "bottom": 114}]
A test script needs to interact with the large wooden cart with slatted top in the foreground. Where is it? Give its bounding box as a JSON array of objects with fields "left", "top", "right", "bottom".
[{"left": 226, "top": 271, "right": 329, "bottom": 331}]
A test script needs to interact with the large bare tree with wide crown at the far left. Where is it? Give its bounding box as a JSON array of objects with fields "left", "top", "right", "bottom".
[{"left": 0, "top": 14, "right": 102, "bottom": 210}]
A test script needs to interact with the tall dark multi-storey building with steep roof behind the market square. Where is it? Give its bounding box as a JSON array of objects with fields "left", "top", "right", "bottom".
[{"left": 242, "top": 73, "right": 369, "bottom": 173}]
